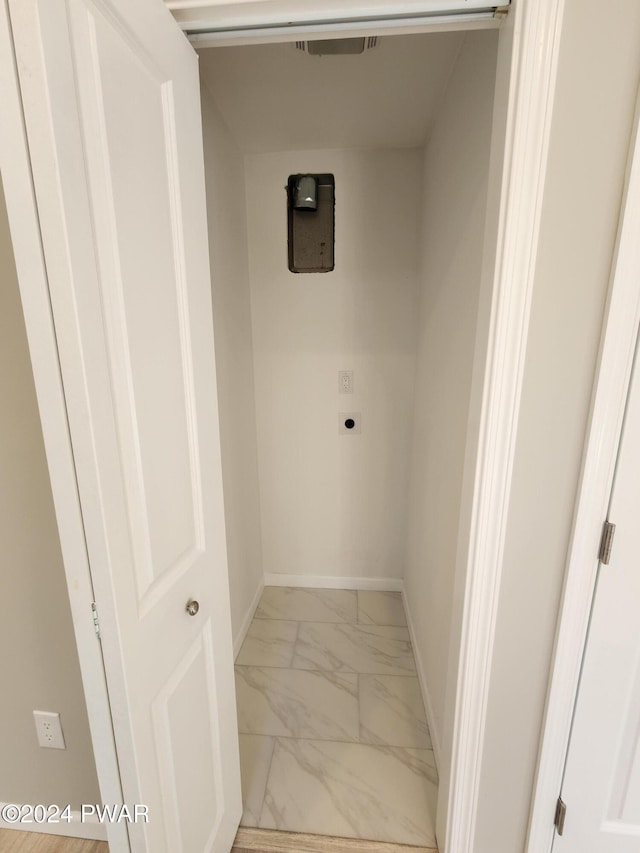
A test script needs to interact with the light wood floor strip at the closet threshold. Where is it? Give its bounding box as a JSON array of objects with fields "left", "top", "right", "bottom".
[{"left": 231, "top": 827, "right": 438, "bottom": 853}]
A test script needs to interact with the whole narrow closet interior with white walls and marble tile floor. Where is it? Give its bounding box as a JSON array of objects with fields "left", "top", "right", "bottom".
[{"left": 200, "top": 30, "right": 498, "bottom": 848}]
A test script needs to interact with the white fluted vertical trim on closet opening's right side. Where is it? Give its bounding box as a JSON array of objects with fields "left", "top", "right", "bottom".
[{"left": 444, "top": 0, "right": 564, "bottom": 853}]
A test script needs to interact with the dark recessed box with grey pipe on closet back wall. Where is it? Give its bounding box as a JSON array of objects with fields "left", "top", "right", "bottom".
[{"left": 287, "top": 175, "right": 335, "bottom": 272}]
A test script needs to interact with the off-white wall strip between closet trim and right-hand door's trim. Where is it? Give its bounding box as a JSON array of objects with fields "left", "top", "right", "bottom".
[{"left": 473, "top": 0, "right": 640, "bottom": 853}]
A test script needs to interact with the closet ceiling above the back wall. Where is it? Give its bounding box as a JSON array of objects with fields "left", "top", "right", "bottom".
[{"left": 200, "top": 32, "right": 465, "bottom": 153}]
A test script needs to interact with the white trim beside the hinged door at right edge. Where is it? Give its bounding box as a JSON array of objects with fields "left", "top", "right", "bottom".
[{"left": 526, "top": 80, "right": 640, "bottom": 853}]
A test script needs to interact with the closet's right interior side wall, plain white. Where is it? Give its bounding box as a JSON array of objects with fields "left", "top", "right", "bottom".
[{"left": 405, "top": 31, "right": 497, "bottom": 760}]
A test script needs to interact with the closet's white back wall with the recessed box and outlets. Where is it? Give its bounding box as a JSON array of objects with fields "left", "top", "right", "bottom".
[{"left": 246, "top": 149, "right": 422, "bottom": 578}]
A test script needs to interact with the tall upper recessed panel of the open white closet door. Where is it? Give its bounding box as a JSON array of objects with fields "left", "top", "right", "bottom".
[{"left": 72, "top": 0, "right": 203, "bottom": 607}]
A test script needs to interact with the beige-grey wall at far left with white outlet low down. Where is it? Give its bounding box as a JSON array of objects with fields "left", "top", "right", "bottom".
[{"left": 0, "top": 178, "right": 100, "bottom": 809}]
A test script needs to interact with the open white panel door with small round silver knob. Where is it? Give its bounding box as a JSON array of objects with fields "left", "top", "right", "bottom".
[{"left": 10, "top": 0, "right": 241, "bottom": 853}]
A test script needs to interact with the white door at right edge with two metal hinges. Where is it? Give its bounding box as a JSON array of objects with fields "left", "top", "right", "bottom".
[{"left": 553, "top": 336, "right": 640, "bottom": 853}]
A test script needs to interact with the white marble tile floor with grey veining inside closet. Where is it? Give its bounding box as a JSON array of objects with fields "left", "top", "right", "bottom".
[{"left": 236, "top": 587, "right": 438, "bottom": 847}]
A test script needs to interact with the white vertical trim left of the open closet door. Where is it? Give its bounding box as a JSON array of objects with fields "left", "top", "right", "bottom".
[{"left": 0, "top": 0, "right": 129, "bottom": 851}]
